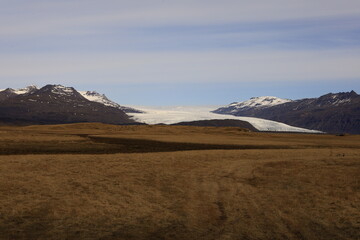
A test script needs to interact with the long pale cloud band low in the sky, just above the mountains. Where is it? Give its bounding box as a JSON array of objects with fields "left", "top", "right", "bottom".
[{"left": 0, "top": 49, "right": 360, "bottom": 84}]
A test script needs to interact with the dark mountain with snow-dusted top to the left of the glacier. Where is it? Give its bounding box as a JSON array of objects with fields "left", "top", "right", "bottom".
[{"left": 0, "top": 85, "right": 135, "bottom": 124}]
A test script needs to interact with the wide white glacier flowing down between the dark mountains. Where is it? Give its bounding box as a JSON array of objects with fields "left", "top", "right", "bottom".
[{"left": 128, "top": 106, "right": 320, "bottom": 133}]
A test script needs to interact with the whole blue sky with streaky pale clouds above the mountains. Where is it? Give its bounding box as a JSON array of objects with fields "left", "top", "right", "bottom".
[{"left": 0, "top": 0, "right": 360, "bottom": 106}]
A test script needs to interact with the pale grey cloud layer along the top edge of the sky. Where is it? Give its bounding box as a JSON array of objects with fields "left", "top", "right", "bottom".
[{"left": 0, "top": 0, "right": 360, "bottom": 36}]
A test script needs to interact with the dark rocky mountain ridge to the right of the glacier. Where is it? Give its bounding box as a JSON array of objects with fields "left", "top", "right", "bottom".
[{"left": 213, "top": 91, "right": 360, "bottom": 134}]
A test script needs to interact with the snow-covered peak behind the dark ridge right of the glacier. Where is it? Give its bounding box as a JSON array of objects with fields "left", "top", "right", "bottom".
[{"left": 214, "top": 96, "right": 292, "bottom": 114}]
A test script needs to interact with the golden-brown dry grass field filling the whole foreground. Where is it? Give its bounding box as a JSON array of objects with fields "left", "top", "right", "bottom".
[{"left": 0, "top": 124, "right": 360, "bottom": 240}]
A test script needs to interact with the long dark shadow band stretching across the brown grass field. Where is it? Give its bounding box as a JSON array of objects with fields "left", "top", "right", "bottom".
[{"left": 0, "top": 134, "right": 298, "bottom": 155}]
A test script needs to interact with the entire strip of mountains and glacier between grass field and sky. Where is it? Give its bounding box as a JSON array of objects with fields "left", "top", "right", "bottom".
[{"left": 0, "top": 85, "right": 360, "bottom": 134}]
